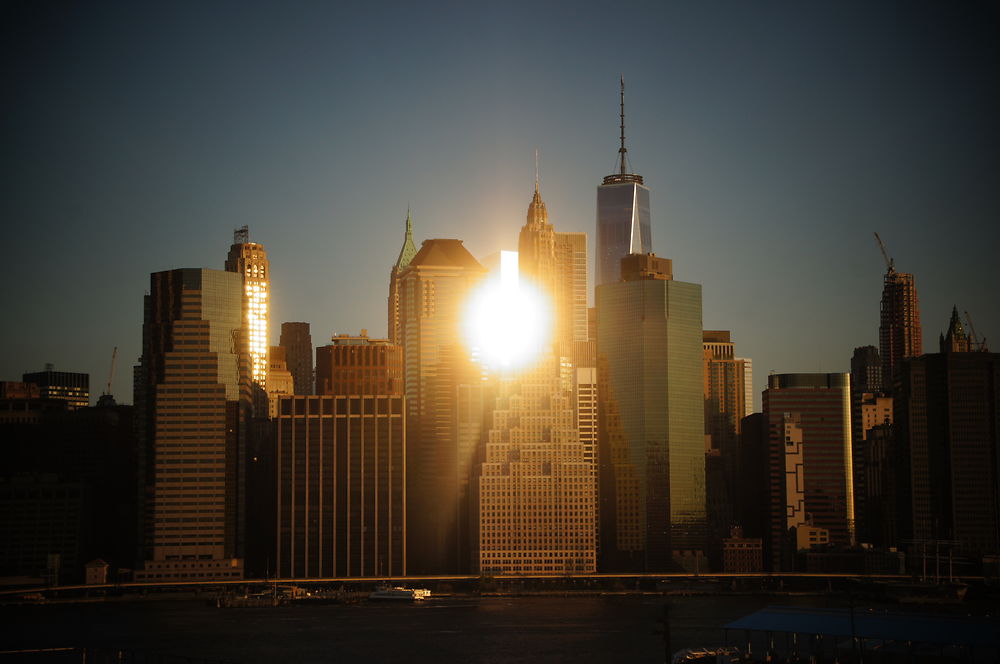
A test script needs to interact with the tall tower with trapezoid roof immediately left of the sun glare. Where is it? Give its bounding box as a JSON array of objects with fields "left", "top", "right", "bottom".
[{"left": 398, "top": 239, "right": 485, "bottom": 573}]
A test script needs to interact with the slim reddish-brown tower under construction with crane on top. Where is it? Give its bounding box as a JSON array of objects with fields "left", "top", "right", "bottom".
[{"left": 878, "top": 264, "right": 924, "bottom": 391}]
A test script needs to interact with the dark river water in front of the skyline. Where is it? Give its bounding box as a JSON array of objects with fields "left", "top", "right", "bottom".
[{"left": 0, "top": 595, "right": 960, "bottom": 664}]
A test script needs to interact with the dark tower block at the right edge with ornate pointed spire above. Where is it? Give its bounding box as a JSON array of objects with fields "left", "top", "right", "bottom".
[{"left": 894, "top": 310, "right": 1000, "bottom": 558}]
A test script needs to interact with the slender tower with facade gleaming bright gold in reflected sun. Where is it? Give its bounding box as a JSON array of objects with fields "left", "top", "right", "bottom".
[{"left": 226, "top": 226, "right": 271, "bottom": 388}]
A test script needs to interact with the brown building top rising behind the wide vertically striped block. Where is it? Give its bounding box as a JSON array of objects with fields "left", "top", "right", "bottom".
[{"left": 316, "top": 330, "right": 405, "bottom": 395}]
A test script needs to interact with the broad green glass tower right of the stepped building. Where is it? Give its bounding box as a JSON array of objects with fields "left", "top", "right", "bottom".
[{"left": 597, "top": 255, "right": 706, "bottom": 572}]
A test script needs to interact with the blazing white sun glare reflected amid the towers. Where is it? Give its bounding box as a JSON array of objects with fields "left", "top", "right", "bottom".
[{"left": 464, "top": 251, "right": 552, "bottom": 370}]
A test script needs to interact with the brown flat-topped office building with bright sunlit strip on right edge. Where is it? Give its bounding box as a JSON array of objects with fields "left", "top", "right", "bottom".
[{"left": 764, "top": 373, "right": 854, "bottom": 571}]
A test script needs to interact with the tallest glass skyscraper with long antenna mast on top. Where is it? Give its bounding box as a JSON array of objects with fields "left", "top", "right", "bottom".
[{"left": 596, "top": 77, "right": 653, "bottom": 286}]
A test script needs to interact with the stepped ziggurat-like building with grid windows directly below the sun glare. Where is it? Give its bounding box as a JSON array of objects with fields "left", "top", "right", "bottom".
[{"left": 478, "top": 355, "right": 597, "bottom": 575}]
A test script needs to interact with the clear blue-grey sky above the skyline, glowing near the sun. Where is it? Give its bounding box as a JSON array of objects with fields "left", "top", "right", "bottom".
[{"left": 0, "top": 1, "right": 1000, "bottom": 402}]
